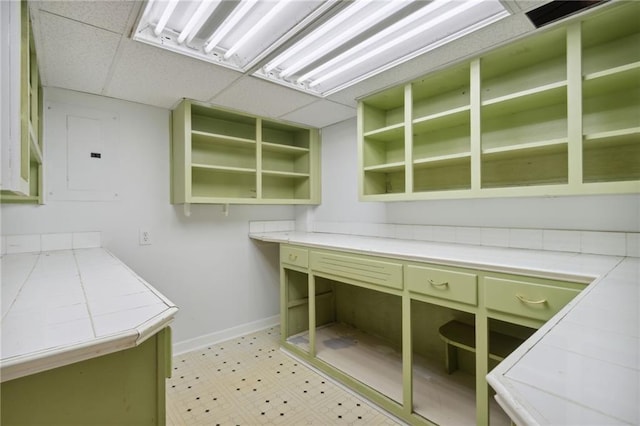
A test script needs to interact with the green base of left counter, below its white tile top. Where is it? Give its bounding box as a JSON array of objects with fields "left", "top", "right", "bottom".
[{"left": 0, "top": 328, "right": 171, "bottom": 426}]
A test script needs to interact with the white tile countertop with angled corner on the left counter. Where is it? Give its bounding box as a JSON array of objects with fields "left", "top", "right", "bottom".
[{"left": 0, "top": 248, "right": 178, "bottom": 382}]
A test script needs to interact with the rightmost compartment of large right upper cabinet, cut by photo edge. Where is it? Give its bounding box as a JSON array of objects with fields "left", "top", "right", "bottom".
[{"left": 581, "top": 2, "right": 640, "bottom": 188}]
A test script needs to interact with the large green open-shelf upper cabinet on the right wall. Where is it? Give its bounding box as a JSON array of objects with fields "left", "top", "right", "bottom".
[{"left": 358, "top": 2, "right": 640, "bottom": 201}]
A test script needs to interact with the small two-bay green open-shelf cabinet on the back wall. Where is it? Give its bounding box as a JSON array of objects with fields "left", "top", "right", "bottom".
[{"left": 172, "top": 100, "right": 320, "bottom": 204}]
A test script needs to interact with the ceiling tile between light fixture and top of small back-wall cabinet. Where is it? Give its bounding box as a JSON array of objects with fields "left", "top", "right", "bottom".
[{"left": 104, "top": 39, "right": 241, "bottom": 108}]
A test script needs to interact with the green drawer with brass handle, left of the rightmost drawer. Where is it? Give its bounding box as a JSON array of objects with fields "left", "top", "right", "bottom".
[{"left": 407, "top": 265, "right": 478, "bottom": 306}]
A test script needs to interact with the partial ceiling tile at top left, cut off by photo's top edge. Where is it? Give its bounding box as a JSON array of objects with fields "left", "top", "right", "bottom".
[{"left": 32, "top": 1, "right": 140, "bottom": 33}]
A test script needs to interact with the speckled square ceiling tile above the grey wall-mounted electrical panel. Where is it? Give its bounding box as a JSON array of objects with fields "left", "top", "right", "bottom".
[{"left": 37, "top": 12, "right": 121, "bottom": 93}]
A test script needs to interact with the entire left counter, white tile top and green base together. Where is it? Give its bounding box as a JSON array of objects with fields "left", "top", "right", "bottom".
[{"left": 0, "top": 248, "right": 178, "bottom": 425}]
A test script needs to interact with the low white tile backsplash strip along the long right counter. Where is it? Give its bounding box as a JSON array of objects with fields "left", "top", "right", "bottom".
[{"left": 249, "top": 221, "right": 640, "bottom": 257}]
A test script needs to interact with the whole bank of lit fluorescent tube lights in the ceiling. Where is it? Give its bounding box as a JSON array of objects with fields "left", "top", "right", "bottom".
[{"left": 133, "top": 0, "right": 508, "bottom": 96}]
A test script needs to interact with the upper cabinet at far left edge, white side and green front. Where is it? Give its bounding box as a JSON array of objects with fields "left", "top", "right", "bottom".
[{"left": 0, "top": 1, "right": 43, "bottom": 204}]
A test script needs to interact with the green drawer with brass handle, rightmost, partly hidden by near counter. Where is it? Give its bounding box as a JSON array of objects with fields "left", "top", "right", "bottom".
[{"left": 484, "top": 277, "right": 580, "bottom": 321}]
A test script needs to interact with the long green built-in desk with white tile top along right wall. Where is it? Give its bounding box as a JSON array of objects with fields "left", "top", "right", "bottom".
[{"left": 251, "top": 232, "right": 640, "bottom": 424}]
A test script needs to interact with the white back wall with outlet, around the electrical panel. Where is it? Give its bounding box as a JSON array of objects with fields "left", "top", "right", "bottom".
[{"left": 1, "top": 89, "right": 295, "bottom": 342}]
